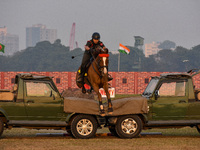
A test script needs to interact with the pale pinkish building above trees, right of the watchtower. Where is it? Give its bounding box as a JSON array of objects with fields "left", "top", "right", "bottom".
[{"left": 145, "top": 42, "right": 161, "bottom": 57}]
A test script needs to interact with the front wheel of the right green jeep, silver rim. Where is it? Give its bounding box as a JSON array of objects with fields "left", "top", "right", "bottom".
[{"left": 115, "top": 115, "right": 142, "bottom": 138}]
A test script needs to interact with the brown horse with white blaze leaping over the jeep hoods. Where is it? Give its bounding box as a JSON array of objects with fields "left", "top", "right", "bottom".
[{"left": 76, "top": 47, "right": 113, "bottom": 116}]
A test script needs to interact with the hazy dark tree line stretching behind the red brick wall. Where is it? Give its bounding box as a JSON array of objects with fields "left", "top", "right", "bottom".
[{"left": 0, "top": 39, "right": 200, "bottom": 72}]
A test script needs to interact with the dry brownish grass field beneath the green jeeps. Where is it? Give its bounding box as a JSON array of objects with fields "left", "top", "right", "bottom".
[{"left": 0, "top": 127, "right": 200, "bottom": 150}]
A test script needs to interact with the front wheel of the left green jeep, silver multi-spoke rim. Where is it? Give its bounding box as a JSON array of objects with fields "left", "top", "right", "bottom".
[{"left": 70, "top": 115, "right": 97, "bottom": 139}]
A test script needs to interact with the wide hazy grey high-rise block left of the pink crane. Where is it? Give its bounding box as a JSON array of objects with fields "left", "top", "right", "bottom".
[{"left": 26, "top": 24, "right": 57, "bottom": 47}]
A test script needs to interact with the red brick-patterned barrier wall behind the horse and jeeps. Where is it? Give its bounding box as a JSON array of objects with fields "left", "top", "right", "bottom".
[{"left": 0, "top": 72, "right": 200, "bottom": 94}]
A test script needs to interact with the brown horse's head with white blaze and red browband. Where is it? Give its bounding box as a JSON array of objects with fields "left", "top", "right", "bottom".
[{"left": 99, "top": 54, "right": 109, "bottom": 76}]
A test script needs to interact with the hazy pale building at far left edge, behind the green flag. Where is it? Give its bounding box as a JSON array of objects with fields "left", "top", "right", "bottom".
[{"left": 0, "top": 26, "right": 19, "bottom": 55}]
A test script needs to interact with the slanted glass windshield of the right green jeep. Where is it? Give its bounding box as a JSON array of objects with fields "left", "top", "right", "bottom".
[{"left": 142, "top": 78, "right": 159, "bottom": 97}]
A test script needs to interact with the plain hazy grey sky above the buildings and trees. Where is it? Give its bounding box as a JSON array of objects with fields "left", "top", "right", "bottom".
[{"left": 0, "top": 0, "right": 200, "bottom": 50}]
